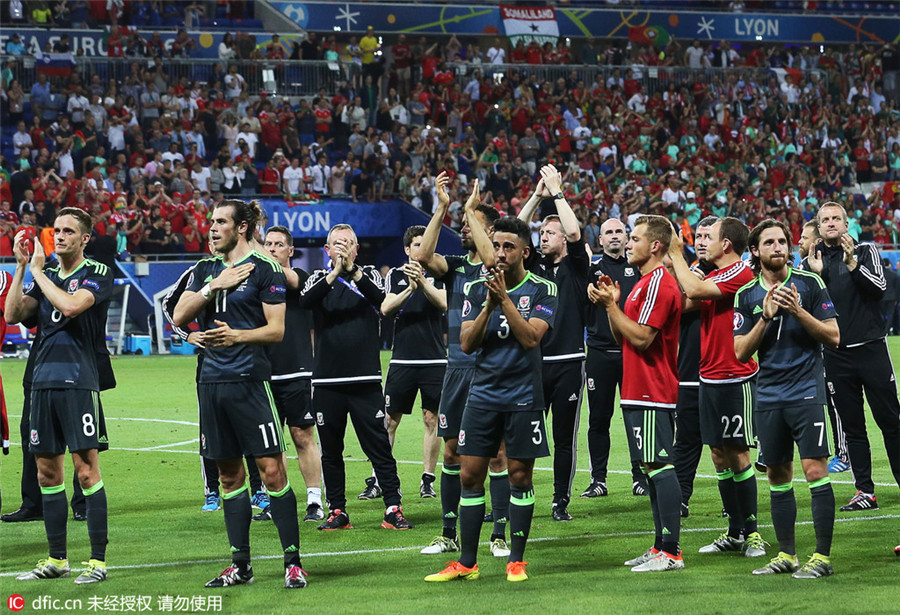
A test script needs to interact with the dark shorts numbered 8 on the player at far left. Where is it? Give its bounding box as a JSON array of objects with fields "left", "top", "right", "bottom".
[{"left": 29, "top": 389, "right": 109, "bottom": 455}]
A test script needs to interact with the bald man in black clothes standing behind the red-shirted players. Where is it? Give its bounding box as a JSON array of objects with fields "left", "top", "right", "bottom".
[{"left": 581, "top": 218, "right": 647, "bottom": 498}]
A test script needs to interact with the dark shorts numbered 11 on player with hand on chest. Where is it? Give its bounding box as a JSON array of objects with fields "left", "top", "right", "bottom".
[{"left": 197, "top": 380, "right": 285, "bottom": 459}]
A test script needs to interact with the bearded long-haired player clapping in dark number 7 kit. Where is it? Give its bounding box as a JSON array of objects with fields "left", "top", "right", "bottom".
[{"left": 734, "top": 220, "right": 841, "bottom": 579}]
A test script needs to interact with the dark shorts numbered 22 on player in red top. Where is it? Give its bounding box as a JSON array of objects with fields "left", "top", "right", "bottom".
[{"left": 700, "top": 376, "right": 756, "bottom": 448}]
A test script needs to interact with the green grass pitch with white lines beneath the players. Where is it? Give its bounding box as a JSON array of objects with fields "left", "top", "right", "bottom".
[{"left": 0, "top": 338, "right": 900, "bottom": 615}]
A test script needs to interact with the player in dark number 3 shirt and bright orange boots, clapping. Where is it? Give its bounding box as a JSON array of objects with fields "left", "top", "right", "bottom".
[{"left": 425, "top": 218, "right": 557, "bottom": 581}]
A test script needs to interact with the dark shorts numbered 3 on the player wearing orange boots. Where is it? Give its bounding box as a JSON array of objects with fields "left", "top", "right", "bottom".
[{"left": 456, "top": 408, "right": 550, "bottom": 459}]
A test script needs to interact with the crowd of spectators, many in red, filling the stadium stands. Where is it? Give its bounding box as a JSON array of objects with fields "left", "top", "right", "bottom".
[{"left": 0, "top": 23, "right": 900, "bottom": 264}]
